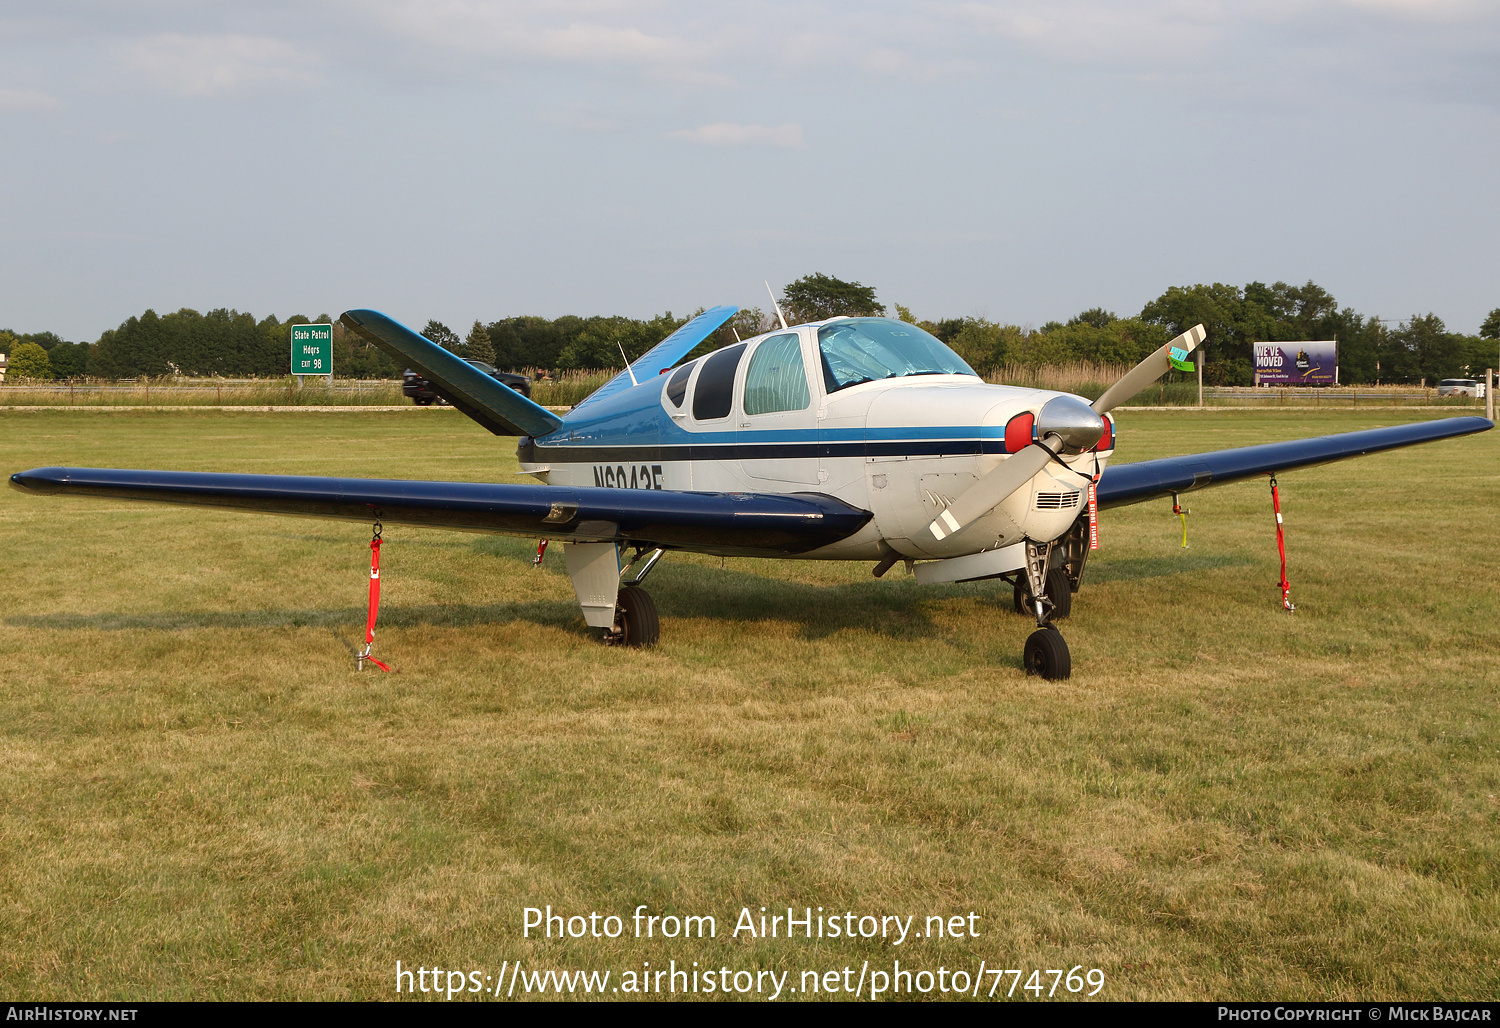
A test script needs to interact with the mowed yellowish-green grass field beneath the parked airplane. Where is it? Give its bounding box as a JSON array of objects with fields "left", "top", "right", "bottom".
[{"left": 0, "top": 411, "right": 1500, "bottom": 999}]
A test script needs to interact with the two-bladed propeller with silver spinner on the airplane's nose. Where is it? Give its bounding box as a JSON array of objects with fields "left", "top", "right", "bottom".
[{"left": 927, "top": 324, "right": 1208, "bottom": 539}]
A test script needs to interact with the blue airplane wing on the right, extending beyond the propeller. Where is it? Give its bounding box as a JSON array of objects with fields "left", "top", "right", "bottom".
[{"left": 1098, "top": 417, "right": 1494, "bottom": 507}]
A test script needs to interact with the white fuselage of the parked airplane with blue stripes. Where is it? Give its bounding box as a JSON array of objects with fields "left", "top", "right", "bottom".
[{"left": 519, "top": 323, "right": 1113, "bottom": 560}]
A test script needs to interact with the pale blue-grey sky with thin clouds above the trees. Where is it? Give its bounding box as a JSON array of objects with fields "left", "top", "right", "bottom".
[{"left": 0, "top": 0, "right": 1500, "bottom": 339}]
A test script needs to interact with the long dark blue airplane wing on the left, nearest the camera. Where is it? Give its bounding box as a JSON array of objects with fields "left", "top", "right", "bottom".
[{"left": 11, "top": 468, "right": 872, "bottom": 555}]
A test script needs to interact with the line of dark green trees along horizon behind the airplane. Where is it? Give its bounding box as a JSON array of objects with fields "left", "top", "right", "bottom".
[{"left": 0, "top": 273, "right": 1500, "bottom": 386}]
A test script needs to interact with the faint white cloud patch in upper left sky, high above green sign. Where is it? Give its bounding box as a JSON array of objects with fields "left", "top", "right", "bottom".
[{"left": 119, "top": 33, "right": 318, "bottom": 96}]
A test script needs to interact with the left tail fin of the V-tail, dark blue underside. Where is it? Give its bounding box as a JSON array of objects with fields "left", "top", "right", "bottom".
[{"left": 339, "top": 304, "right": 563, "bottom": 435}]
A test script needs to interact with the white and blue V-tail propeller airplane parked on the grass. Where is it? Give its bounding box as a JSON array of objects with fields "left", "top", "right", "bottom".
[{"left": 11, "top": 306, "right": 1493, "bottom": 678}]
